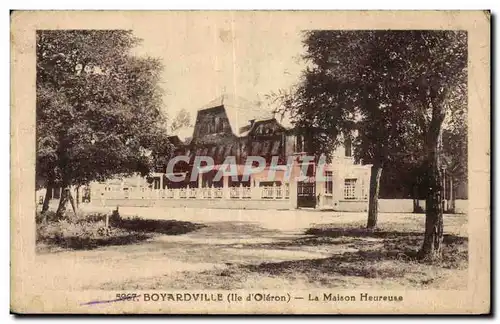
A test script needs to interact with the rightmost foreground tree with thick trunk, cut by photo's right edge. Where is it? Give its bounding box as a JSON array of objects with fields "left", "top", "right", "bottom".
[{"left": 408, "top": 31, "right": 467, "bottom": 260}]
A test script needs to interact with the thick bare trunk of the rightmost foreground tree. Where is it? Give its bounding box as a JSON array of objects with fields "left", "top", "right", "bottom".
[{"left": 419, "top": 130, "right": 443, "bottom": 261}]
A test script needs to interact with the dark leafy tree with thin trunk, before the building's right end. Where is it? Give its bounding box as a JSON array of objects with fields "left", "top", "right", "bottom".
[{"left": 270, "top": 31, "right": 426, "bottom": 228}]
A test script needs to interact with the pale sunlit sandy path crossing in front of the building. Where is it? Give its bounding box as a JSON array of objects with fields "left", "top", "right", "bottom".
[{"left": 33, "top": 208, "right": 466, "bottom": 290}]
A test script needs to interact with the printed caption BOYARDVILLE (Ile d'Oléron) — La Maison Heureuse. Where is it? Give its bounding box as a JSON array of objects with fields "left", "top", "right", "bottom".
[{"left": 139, "top": 292, "right": 403, "bottom": 302}]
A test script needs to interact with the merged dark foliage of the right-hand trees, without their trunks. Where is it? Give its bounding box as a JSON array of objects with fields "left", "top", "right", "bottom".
[{"left": 280, "top": 30, "right": 466, "bottom": 163}]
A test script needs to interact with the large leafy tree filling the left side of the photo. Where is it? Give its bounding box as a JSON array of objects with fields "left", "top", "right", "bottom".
[{"left": 36, "top": 30, "right": 169, "bottom": 216}]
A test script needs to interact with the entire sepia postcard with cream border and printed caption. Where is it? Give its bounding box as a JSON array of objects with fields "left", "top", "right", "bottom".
[{"left": 11, "top": 11, "right": 490, "bottom": 314}]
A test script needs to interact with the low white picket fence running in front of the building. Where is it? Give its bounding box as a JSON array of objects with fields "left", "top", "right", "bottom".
[{"left": 98, "top": 184, "right": 290, "bottom": 200}]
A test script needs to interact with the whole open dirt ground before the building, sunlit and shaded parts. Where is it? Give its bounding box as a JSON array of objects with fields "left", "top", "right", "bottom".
[{"left": 34, "top": 208, "right": 467, "bottom": 291}]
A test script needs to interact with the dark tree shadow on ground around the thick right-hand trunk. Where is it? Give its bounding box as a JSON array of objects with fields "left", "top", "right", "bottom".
[{"left": 245, "top": 228, "right": 468, "bottom": 279}]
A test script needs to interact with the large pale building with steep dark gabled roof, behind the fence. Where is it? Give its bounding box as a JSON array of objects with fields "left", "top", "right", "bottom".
[{"left": 90, "top": 96, "right": 371, "bottom": 211}]
